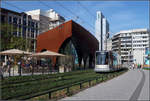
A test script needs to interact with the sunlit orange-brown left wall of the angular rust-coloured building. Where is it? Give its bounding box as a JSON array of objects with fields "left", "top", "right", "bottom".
[{"left": 37, "top": 20, "right": 72, "bottom": 52}]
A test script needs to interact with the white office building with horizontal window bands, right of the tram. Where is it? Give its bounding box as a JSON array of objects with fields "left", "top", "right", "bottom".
[{"left": 112, "top": 29, "right": 149, "bottom": 65}]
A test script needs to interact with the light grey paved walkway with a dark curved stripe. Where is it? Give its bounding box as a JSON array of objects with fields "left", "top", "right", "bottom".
[{"left": 61, "top": 69, "right": 150, "bottom": 101}]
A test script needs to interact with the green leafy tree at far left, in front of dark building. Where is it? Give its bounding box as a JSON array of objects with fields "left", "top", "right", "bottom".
[{"left": 0, "top": 23, "right": 31, "bottom": 50}]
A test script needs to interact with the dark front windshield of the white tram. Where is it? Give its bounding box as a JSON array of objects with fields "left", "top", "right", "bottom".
[{"left": 96, "top": 52, "right": 108, "bottom": 65}]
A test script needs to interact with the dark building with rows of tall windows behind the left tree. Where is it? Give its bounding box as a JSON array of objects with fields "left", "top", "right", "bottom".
[{"left": 1, "top": 8, "right": 39, "bottom": 51}]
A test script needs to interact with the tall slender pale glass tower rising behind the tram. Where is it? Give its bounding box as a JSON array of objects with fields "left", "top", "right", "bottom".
[{"left": 95, "top": 11, "right": 109, "bottom": 50}]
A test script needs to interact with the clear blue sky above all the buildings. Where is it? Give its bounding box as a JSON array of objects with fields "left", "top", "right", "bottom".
[{"left": 1, "top": 0, "right": 149, "bottom": 36}]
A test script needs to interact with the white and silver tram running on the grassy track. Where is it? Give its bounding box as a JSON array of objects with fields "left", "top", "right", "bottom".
[{"left": 94, "top": 51, "right": 121, "bottom": 72}]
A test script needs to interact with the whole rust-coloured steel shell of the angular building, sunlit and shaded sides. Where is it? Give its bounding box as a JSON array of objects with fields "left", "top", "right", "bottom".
[{"left": 37, "top": 20, "right": 99, "bottom": 67}]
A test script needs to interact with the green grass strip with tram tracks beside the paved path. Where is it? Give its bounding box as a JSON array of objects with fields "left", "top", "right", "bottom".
[{"left": 0, "top": 69, "right": 127, "bottom": 101}]
